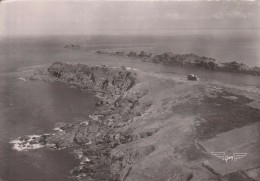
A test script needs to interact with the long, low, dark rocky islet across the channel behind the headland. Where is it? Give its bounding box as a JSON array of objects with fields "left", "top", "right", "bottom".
[{"left": 96, "top": 51, "right": 260, "bottom": 76}]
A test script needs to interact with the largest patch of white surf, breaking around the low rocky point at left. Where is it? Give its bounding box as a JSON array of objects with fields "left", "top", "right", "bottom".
[{"left": 10, "top": 135, "right": 44, "bottom": 151}]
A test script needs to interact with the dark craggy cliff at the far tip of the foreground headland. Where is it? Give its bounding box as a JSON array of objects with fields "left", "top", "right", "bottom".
[{"left": 48, "top": 62, "right": 138, "bottom": 101}]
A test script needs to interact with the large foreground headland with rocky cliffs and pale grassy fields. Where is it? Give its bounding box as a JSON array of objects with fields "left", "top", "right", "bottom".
[{"left": 12, "top": 61, "right": 260, "bottom": 181}]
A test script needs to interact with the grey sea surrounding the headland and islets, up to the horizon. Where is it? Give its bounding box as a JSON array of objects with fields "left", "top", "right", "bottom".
[{"left": 0, "top": 34, "right": 260, "bottom": 181}]
